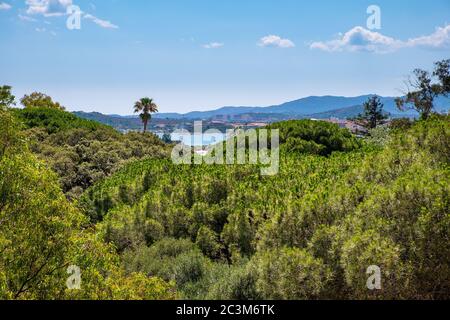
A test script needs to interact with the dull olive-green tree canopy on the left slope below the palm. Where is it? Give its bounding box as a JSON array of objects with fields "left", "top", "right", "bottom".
[{"left": 12, "top": 108, "right": 168, "bottom": 198}]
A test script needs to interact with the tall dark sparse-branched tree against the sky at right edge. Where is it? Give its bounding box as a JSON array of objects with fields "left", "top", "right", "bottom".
[{"left": 396, "top": 59, "right": 450, "bottom": 120}]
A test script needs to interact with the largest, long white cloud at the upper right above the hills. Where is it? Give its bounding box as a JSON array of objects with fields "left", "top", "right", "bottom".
[{"left": 310, "top": 25, "right": 450, "bottom": 53}]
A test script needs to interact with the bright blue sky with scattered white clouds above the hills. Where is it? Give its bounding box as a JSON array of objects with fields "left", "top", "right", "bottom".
[{"left": 0, "top": 0, "right": 450, "bottom": 114}]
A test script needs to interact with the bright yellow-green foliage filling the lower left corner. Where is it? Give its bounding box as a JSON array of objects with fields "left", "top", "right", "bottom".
[{"left": 0, "top": 111, "right": 176, "bottom": 299}]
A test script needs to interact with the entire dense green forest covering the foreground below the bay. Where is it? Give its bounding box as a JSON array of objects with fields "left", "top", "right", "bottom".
[{"left": 0, "top": 60, "right": 450, "bottom": 300}]
